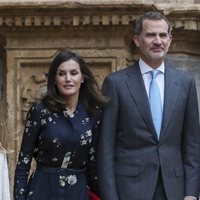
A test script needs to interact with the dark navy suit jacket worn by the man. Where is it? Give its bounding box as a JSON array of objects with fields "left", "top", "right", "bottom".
[{"left": 98, "top": 62, "right": 200, "bottom": 200}]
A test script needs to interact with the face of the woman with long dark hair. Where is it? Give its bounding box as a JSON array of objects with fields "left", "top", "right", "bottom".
[{"left": 55, "top": 59, "right": 83, "bottom": 98}]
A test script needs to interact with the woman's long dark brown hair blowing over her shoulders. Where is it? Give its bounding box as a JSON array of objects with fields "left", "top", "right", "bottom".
[{"left": 42, "top": 48, "right": 108, "bottom": 113}]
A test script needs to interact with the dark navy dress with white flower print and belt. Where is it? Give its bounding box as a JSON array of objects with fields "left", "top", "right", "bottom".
[{"left": 14, "top": 103, "right": 101, "bottom": 200}]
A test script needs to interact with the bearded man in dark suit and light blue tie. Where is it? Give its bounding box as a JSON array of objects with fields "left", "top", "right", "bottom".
[{"left": 98, "top": 12, "right": 200, "bottom": 200}]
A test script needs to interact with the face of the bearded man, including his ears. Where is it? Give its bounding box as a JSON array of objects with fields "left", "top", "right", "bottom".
[{"left": 134, "top": 19, "right": 172, "bottom": 67}]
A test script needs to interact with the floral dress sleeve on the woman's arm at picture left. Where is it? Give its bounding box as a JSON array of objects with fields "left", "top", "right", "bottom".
[{"left": 14, "top": 104, "right": 41, "bottom": 200}]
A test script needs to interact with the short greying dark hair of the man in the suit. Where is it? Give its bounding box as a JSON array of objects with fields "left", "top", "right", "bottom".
[{"left": 135, "top": 12, "right": 171, "bottom": 35}]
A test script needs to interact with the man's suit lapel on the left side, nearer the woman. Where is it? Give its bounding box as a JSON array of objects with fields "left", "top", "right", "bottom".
[{"left": 126, "top": 62, "right": 157, "bottom": 140}]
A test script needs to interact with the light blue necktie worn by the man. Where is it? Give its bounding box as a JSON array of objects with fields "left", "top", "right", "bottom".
[{"left": 149, "top": 70, "right": 162, "bottom": 138}]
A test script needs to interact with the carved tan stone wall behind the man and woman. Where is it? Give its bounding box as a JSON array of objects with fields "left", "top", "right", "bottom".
[{"left": 0, "top": 0, "right": 200, "bottom": 198}]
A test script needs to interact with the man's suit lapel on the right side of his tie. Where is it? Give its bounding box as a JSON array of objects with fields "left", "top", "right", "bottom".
[{"left": 160, "top": 64, "right": 180, "bottom": 141}]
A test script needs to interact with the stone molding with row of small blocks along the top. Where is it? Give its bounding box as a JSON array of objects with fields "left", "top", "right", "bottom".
[{"left": 0, "top": 2, "right": 200, "bottom": 31}]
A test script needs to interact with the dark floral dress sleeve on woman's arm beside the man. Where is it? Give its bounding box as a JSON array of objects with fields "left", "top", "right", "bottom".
[{"left": 87, "top": 109, "right": 101, "bottom": 194}]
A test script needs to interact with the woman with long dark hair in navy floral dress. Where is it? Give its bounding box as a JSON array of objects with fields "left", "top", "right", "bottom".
[{"left": 14, "top": 49, "right": 107, "bottom": 200}]
